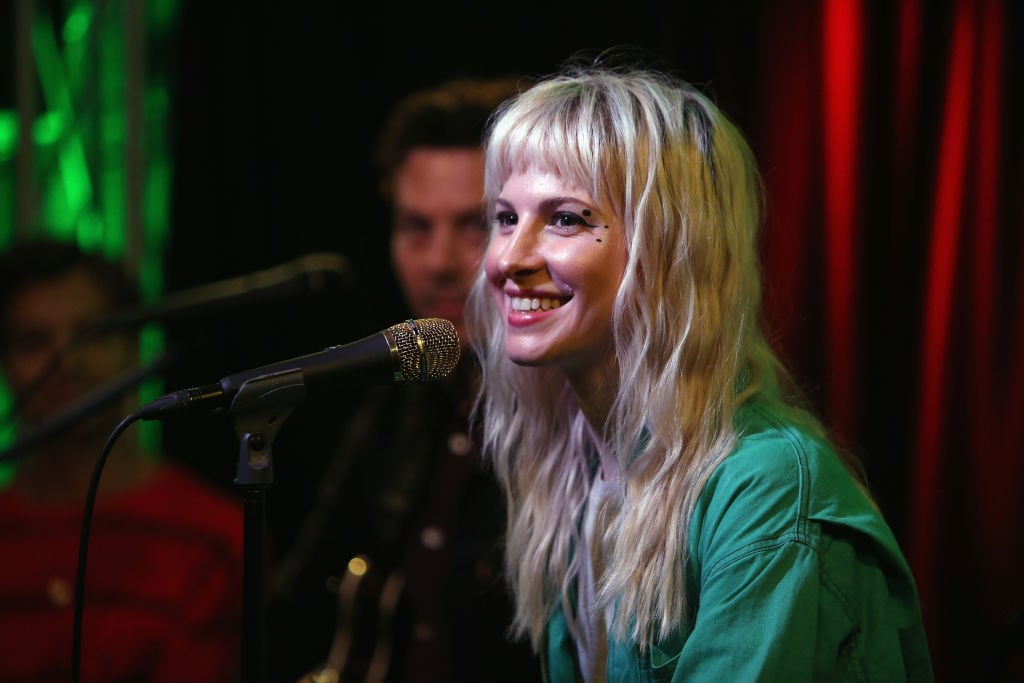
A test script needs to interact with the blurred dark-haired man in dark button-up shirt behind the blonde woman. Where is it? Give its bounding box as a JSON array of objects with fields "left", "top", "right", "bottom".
[{"left": 270, "top": 79, "right": 540, "bottom": 683}]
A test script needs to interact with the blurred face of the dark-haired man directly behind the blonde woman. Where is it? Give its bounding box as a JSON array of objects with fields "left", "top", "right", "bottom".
[{"left": 391, "top": 147, "right": 487, "bottom": 343}]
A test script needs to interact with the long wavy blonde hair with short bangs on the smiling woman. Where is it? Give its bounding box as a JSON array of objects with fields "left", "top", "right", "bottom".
[{"left": 467, "top": 66, "right": 835, "bottom": 648}]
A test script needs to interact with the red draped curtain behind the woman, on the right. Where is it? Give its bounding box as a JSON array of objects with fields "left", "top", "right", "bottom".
[{"left": 753, "top": 0, "right": 1024, "bottom": 681}]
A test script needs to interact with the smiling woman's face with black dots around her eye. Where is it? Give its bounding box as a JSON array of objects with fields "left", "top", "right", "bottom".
[{"left": 484, "top": 169, "right": 627, "bottom": 379}]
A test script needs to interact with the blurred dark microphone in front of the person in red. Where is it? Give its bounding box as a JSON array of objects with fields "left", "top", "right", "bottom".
[{"left": 88, "top": 252, "right": 352, "bottom": 334}]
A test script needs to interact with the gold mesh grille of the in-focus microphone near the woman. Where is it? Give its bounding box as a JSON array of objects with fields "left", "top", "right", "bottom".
[{"left": 388, "top": 317, "right": 462, "bottom": 382}]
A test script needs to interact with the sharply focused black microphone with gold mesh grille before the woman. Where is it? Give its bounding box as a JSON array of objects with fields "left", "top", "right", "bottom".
[{"left": 139, "top": 317, "right": 462, "bottom": 420}]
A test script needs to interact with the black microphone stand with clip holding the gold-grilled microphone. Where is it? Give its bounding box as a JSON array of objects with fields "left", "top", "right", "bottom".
[{"left": 230, "top": 370, "right": 306, "bottom": 683}]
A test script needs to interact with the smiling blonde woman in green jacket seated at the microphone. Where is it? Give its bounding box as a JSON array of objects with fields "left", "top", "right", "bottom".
[{"left": 468, "top": 60, "right": 933, "bottom": 683}]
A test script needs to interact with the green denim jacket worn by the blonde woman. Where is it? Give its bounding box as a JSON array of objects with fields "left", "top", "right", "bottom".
[{"left": 542, "top": 408, "right": 934, "bottom": 683}]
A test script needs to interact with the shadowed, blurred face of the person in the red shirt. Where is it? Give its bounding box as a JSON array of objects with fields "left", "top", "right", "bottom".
[{"left": 2, "top": 269, "right": 138, "bottom": 430}]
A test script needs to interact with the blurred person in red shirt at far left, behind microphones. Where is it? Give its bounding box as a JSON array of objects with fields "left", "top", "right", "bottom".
[{"left": 0, "top": 240, "right": 243, "bottom": 683}]
